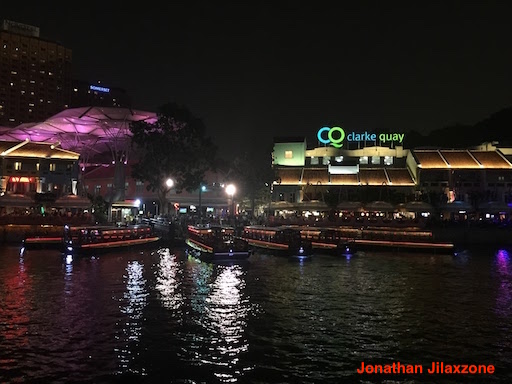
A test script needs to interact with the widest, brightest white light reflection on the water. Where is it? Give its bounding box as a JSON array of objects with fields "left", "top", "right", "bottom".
[{"left": 184, "top": 263, "right": 250, "bottom": 382}]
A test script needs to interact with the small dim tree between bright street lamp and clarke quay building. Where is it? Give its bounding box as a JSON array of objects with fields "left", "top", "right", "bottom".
[{"left": 229, "top": 150, "right": 277, "bottom": 218}]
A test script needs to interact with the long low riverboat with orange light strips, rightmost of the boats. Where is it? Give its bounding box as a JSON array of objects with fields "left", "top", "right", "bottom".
[{"left": 301, "top": 226, "right": 455, "bottom": 253}]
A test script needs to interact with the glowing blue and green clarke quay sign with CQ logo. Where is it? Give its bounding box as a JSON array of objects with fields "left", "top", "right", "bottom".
[{"left": 316, "top": 127, "right": 405, "bottom": 148}]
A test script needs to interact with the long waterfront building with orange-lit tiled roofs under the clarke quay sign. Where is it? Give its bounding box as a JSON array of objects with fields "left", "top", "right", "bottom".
[{"left": 270, "top": 132, "right": 512, "bottom": 219}]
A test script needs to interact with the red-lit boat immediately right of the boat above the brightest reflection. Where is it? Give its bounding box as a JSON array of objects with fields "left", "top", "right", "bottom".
[{"left": 242, "top": 225, "right": 313, "bottom": 258}]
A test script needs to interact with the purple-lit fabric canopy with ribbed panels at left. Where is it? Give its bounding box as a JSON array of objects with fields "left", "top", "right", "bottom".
[{"left": 0, "top": 107, "right": 157, "bottom": 164}]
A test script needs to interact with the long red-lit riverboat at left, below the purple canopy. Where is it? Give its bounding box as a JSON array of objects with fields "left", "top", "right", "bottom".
[{"left": 64, "top": 225, "right": 160, "bottom": 253}]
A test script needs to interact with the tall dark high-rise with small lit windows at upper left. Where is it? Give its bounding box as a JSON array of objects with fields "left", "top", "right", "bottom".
[{"left": 0, "top": 20, "right": 72, "bottom": 127}]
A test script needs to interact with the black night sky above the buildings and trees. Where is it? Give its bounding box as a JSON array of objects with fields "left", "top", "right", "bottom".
[{"left": 0, "top": 1, "right": 512, "bottom": 156}]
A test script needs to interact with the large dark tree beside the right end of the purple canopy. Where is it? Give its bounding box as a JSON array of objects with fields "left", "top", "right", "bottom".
[{"left": 130, "top": 103, "right": 217, "bottom": 213}]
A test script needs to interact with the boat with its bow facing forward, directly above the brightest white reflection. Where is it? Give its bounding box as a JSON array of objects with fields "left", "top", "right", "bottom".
[{"left": 185, "top": 224, "right": 250, "bottom": 261}]
